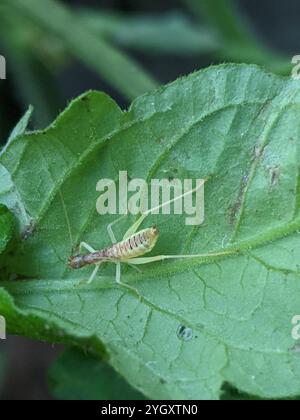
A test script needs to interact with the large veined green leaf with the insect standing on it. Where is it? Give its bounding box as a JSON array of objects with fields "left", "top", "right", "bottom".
[{"left": 0, "top": 65, "right": 300, "bottom": 399}]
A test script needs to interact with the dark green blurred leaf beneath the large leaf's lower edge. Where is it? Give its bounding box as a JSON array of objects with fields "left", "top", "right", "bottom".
[{"left": 49, "top": 349, "right": 143, "bottom": 400}]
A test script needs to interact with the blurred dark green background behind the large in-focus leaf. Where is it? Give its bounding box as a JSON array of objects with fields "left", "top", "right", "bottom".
[{"left": 0, "top": 0, "right": 300, "bottom": 399}]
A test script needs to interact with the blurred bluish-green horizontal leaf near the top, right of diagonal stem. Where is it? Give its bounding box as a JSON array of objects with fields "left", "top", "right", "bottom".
[{"left": 80, "top": 9, "right": 219, "bottom": 55}]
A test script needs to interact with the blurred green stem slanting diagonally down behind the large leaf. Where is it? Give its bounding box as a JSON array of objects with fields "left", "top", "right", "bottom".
[{"left": 4, "top": 0, "right": 157, "bottom": 99}]
